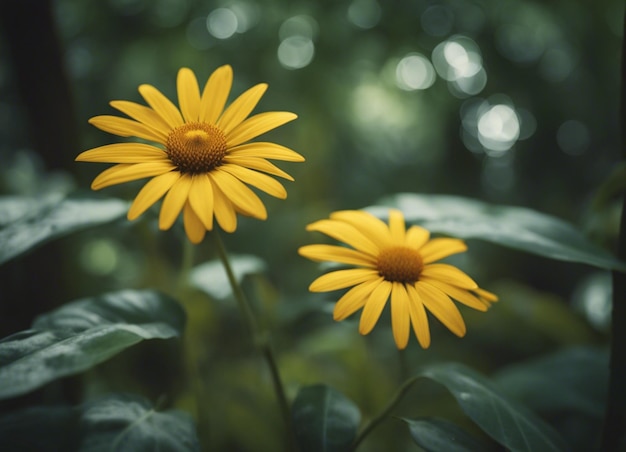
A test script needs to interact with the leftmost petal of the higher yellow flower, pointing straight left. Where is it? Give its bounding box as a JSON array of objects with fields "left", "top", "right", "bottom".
[{"left": 76, "top": 143, "right": 169, "bottom": 163}]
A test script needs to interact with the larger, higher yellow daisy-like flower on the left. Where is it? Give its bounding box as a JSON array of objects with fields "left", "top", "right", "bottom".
[{"left": 76, "top": 66, "right": 304, "bottom": 243}]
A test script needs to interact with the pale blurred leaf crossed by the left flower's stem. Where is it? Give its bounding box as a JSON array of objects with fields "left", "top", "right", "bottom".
[{"left": 185, "top": 254, "right": 266, "bottom": 300}]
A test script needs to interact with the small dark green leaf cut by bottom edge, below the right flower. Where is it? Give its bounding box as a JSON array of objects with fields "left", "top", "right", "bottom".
[{"left": 403, "top": 418, "right": 487, "bottom": 452}]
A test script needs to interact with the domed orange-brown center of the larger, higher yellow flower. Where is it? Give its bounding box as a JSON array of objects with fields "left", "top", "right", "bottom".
[{"left": 165, "top": 122, "right": 227, "bottom": 174}]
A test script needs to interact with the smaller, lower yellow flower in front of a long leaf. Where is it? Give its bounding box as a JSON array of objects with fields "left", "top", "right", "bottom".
[{"left": 298, "top": 210, "right": 498, "bottom": 349}]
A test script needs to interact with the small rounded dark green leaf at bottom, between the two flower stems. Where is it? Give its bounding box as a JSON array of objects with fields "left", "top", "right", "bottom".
[{"left": 292, "top": 385, "right": 361, "bottom": 452}]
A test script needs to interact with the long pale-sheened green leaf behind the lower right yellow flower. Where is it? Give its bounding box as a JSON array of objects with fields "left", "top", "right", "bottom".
[{"left": 367, "top": 193, "right": 626, "bottom": 271}]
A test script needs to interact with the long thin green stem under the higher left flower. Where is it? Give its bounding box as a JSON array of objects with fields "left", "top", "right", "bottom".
[{"left": 211, "top": 230, "right": 295, "bottom": 450}]
